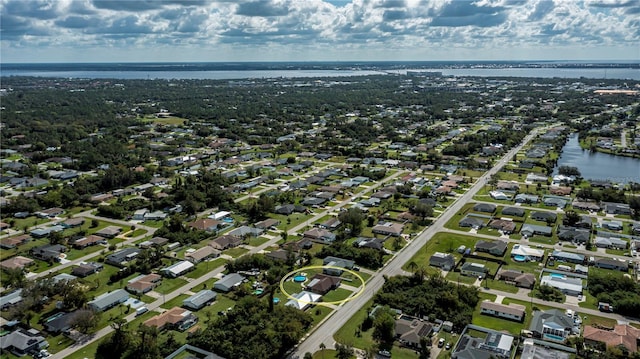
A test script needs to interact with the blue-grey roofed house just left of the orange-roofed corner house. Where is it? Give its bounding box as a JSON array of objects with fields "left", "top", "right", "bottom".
[{"left": 529, "top": 309, "right": 574, "bottom": 343}]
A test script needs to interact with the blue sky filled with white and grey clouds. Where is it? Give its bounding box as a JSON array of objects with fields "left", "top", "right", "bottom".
[{"left": 0, "top": 0, "right": 640, "bottom": 63}]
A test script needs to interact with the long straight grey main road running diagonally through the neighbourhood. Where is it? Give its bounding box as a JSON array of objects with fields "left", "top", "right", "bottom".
[{"left": 292, "top": 130, "right": 539, "bottom": 358}]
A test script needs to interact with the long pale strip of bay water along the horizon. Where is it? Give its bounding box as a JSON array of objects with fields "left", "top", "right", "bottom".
[{"left": 0, "top": 64, "right": 640, "bottom": 80}]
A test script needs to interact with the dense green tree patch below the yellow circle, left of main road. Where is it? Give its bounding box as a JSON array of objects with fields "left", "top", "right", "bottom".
[{"left": 189, "top": 296, "right": 312, "bottom": 359}]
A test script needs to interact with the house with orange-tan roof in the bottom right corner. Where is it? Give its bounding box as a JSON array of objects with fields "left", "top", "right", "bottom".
[{"left": 582, "top": 324, "right": 640, "bottom": 353}]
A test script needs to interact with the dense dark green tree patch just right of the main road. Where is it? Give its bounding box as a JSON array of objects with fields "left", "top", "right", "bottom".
[{"left": 374, "top": 275, "right": 479, "bottom": 331}]
